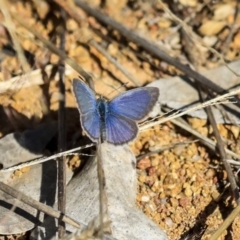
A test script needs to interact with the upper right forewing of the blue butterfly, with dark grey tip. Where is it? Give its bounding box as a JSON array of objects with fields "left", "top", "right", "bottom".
[{"left": 108, "top": 87, "right": 159, "bottom": 121}]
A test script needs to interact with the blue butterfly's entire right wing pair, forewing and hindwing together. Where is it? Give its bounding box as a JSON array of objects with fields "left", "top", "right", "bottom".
[{"left": 106, "top": 87, "right": 159, "bottom": 145}]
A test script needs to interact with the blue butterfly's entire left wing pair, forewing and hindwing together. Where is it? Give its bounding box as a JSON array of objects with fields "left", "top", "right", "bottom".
[{"left": 73, "top": 79, "right": 100, "bottom": 142}]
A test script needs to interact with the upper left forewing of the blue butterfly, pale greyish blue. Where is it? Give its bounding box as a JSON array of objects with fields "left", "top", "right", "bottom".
[{"left": 73, "top": 79, "right": 97, "bottom": 114}]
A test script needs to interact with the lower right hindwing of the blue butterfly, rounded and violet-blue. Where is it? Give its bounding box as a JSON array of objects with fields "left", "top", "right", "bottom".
[{"left": 105, "top": 112, "right": 138, "bottom": 145}]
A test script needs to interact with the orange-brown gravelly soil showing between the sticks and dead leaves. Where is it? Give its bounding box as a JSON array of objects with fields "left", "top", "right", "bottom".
[{"left": 0, "top": 0, "right": 240, "bottom": 240}]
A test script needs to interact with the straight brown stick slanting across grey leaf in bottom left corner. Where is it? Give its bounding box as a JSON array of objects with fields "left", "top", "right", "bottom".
[{"left": 0, "top": 182, "right": 81, "bottom": 228}]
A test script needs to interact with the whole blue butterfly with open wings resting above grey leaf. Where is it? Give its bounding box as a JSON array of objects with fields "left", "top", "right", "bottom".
[{"left": 73, "top": 79, "right": 159, "bottom": 145}]
